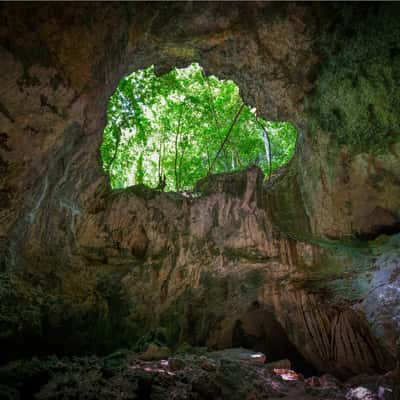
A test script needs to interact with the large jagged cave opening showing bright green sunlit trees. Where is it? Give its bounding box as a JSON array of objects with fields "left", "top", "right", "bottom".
[{"left": 101, "top": 64, "right": 297, "bottom": 192}]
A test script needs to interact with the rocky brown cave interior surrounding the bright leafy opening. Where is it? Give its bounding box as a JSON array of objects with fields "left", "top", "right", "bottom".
[{"left": 0, "top": 1, "right": 400, "bottom": 400}]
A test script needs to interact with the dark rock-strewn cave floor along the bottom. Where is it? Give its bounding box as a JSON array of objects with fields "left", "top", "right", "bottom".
[{"left": 0, "top": 349, "right": 399, "bottom": 400}]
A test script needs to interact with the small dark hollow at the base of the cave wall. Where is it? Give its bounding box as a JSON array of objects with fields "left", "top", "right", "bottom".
[{"left": 232, "top": 308, "right": 318, "bottom": 378}]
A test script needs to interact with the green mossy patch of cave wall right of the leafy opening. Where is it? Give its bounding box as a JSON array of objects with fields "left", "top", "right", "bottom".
[{"left": 307, "top": 7, "right": 400, "bottom": 154}]
